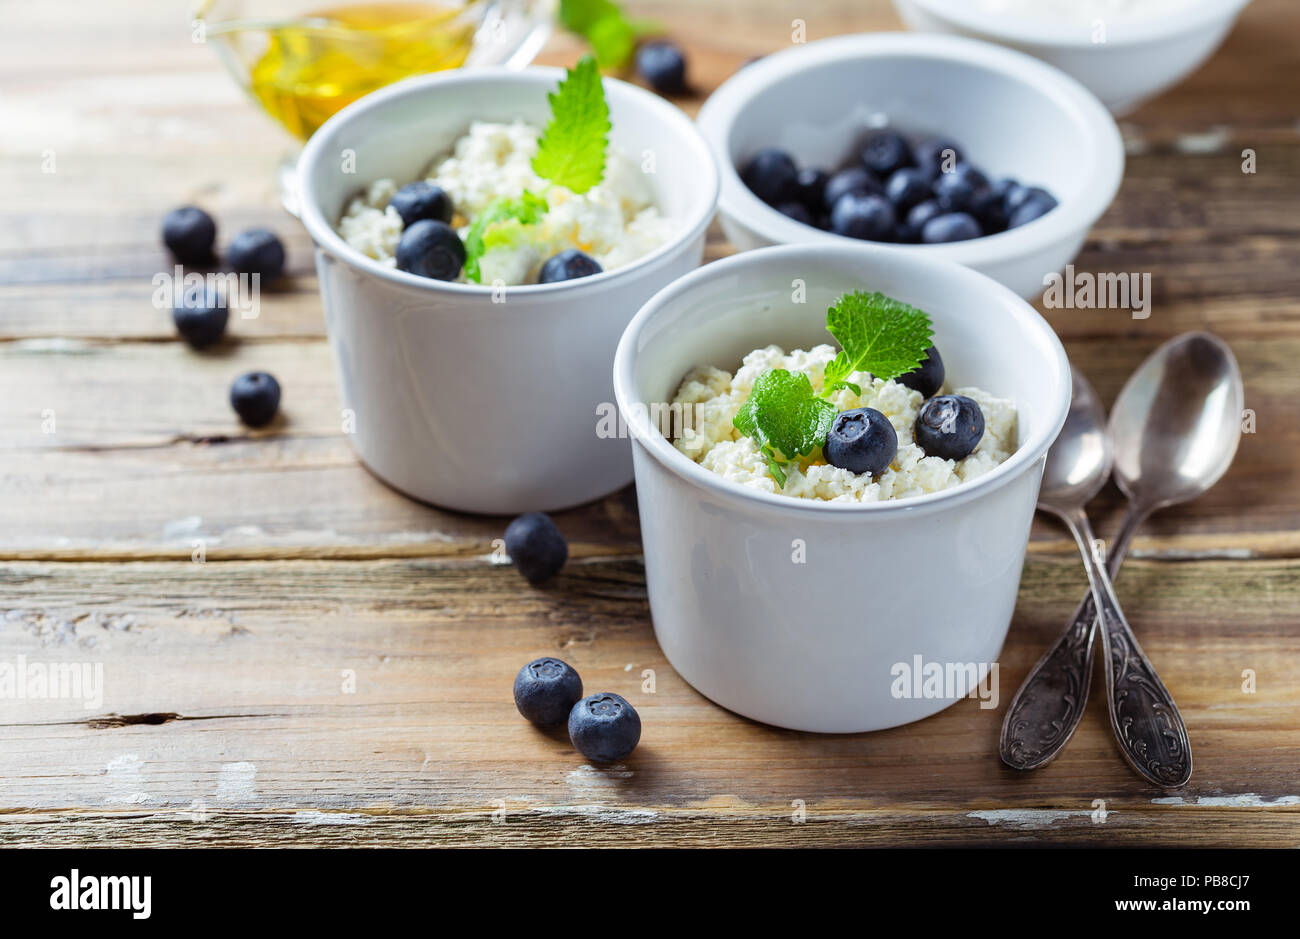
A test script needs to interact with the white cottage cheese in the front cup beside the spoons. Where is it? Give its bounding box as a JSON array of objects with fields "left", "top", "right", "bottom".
[{"left": 672, "top": 346, "right": 1018, "bottom": 502}]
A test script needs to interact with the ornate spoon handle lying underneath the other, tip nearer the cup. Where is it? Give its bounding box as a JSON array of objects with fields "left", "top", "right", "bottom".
[{"left": 1000, "top": 505, "right": 1147, "bottom": 770}]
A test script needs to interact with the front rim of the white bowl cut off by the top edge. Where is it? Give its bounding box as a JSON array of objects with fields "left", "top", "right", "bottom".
[{"left": 894, "top": 0, "right": 1251, "bottom": 49}]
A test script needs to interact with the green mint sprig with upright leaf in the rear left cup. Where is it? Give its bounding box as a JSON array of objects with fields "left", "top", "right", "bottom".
[{"left": 465, "top": 56, "right": 610, "bottom": 284}]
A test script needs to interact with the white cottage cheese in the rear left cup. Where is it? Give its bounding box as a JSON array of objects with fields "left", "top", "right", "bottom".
[{"left": 338, "top": 121, "right": 673, "bottom": 285}]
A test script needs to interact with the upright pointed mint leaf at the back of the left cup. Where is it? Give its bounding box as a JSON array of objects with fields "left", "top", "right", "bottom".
[{"left": 533, "top": 56, "right": 610, "bottom": 194}]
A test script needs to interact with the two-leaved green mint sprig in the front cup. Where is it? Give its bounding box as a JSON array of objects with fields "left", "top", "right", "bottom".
[{"left": 732, "top": 290, "right": 932, "bottom": 489}]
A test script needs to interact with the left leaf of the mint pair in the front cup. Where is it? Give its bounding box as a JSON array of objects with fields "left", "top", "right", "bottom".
[{"left": 732, "top": 368, "right": 836, "bottom": 486}]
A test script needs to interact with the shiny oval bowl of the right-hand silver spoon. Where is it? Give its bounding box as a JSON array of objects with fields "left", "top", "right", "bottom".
[{"left": 1112, "top": 333, "right": 1245, "bottom": 512}]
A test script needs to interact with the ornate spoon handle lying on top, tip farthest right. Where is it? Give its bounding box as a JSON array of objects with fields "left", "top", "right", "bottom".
[{"left": 1066, "top": 509, "right": 1192, "bottom": 788}]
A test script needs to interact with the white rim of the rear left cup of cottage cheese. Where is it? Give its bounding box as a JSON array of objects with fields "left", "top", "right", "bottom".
[{"left": 296, "top": 65, "right": 722, "bottom": 297}]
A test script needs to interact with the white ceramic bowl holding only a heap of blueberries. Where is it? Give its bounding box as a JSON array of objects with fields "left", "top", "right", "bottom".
[{"left": 698, "top": 33, "right": 1125, "bottom": 298}]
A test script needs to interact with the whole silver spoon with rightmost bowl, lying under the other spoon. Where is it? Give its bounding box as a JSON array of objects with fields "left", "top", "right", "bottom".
[{"left": 1001, "top": 333, "right": 1244, "bottom": 786}]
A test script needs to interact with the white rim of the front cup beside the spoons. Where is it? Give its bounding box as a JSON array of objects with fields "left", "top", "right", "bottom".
[{"left": 614, "top": 245, "right": 1071, "bottom": 515}]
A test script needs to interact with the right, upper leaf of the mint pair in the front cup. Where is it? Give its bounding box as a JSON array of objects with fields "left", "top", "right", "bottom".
[{"left": 823, "top": 290, "right": 932, "bottom": 384}]
